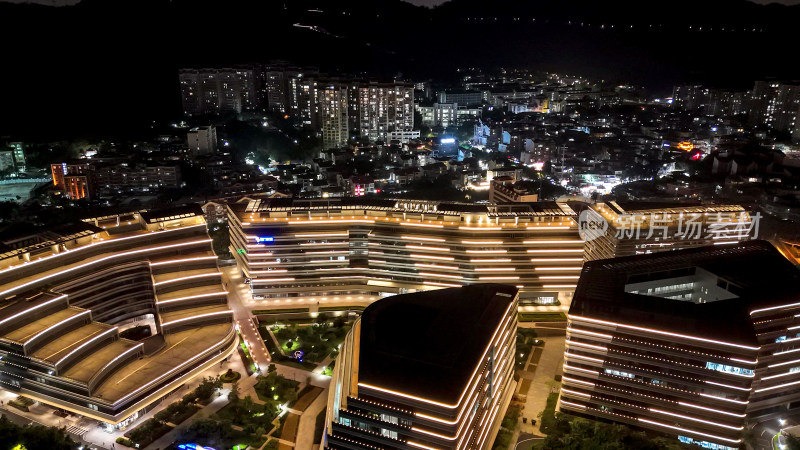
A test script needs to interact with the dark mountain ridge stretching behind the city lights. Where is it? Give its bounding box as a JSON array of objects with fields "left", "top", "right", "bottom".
[{"left": 0, "top": 0, "right": 800, "bottom": 137}]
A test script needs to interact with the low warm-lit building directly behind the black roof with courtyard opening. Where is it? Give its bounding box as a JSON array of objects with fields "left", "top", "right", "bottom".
[{"left": 580, "top": 202, "right": 758, "bottom": 261}]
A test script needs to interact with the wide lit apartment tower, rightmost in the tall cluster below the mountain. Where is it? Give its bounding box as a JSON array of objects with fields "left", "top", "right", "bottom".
[{"left": 359, "top": 82, "right": 414, "bottom": 141}]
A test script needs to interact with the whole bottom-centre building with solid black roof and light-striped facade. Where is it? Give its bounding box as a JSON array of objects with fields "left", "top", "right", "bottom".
[{"left": 322, "top": 284, "right": 517, "bottom": 449}]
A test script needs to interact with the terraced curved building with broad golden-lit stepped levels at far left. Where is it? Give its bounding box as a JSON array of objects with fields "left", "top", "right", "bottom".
[{"left": 0, "top": 205, "right": 236, "bottom": 426}]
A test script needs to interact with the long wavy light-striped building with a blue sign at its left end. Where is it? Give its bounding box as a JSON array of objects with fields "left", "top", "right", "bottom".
[{"left": 228, "top": 198, "right": 583, "bottom": 305}]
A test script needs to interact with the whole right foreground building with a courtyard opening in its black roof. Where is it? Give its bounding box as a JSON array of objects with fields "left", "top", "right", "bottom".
[{"left": 559, "top": 241, "right": 800, "bottom": 450}]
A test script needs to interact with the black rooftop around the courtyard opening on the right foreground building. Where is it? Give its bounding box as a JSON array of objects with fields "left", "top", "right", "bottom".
[{"left": 569, "top": 241, "right": 800, "bottom": 345}]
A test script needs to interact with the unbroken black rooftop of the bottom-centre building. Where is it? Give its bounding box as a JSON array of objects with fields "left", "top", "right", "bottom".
[{"left": 358, "top": 284, "right": 517, "bottom": 403}]
